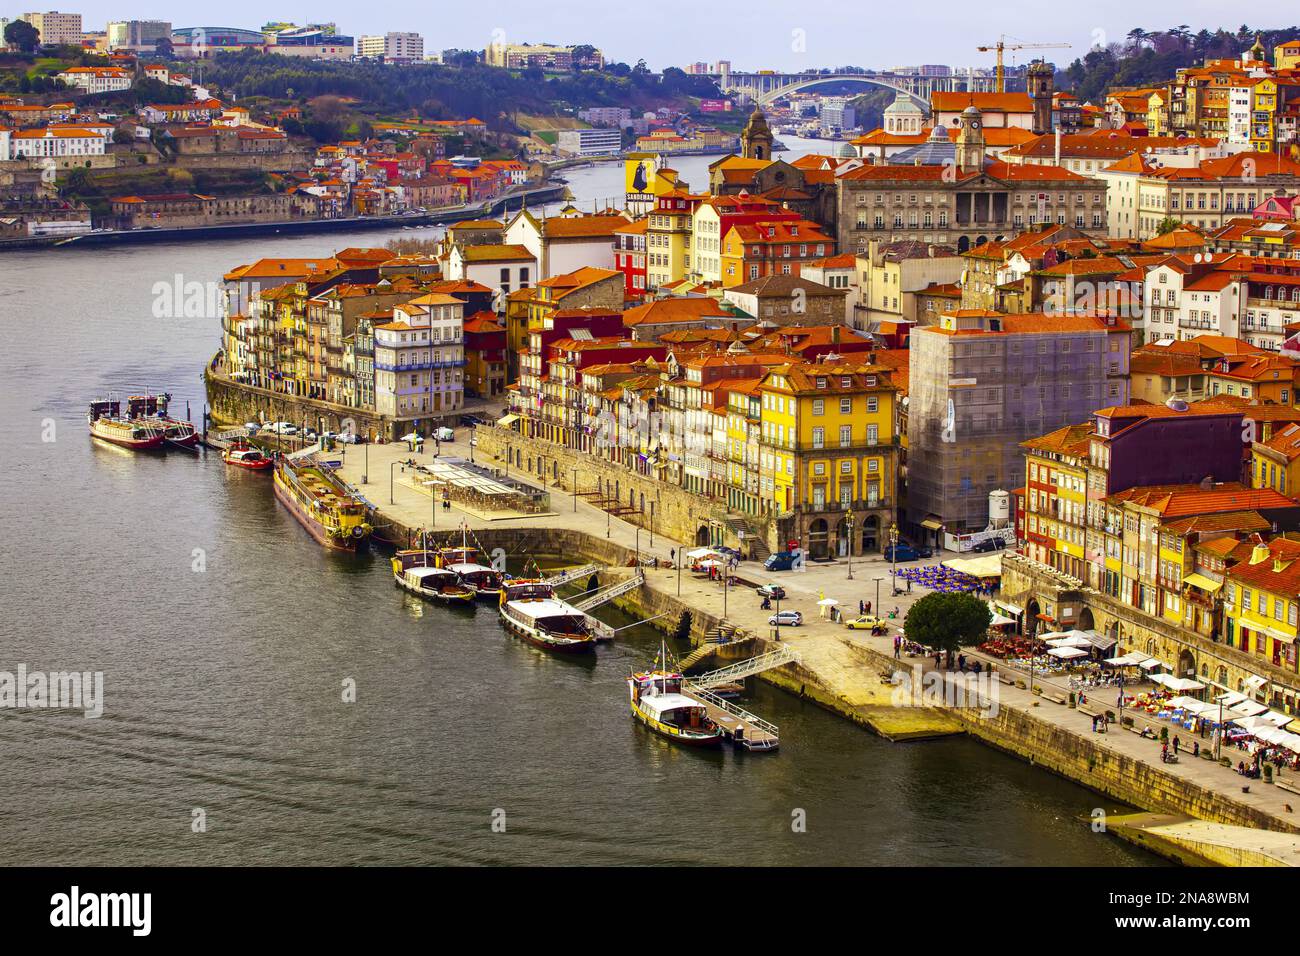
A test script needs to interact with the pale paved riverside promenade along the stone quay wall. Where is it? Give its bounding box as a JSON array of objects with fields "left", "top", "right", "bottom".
[{"left": 329, "top": 429, "right": 1300, "bottom": 862}]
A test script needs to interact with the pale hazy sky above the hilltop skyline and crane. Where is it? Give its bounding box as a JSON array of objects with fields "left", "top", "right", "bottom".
[{"left": 48, "top": 0, "right": 1300, "bottom": 70}]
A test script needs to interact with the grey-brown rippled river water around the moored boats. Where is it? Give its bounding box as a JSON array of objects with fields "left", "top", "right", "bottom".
[{"left": 0, "top": 138, "right": 1156, "bottom": 865}]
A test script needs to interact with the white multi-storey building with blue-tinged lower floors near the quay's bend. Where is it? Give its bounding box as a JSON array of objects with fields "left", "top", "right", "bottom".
[{"left": 374, "top": 293, "right": 465, "bottom": 420}]
